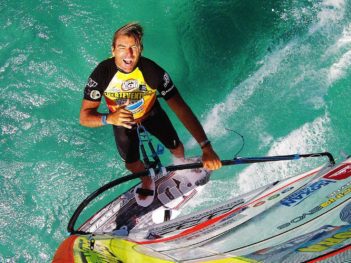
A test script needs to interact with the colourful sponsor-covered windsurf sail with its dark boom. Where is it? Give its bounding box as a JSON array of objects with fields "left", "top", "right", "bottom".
[{"left": 54, "top": 153, "right": 351, "bottom": 263}]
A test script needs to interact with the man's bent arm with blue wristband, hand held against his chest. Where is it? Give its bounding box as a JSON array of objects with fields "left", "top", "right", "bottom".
[{"left": 79, "top": 99, "right": 134, "bottom": 129}]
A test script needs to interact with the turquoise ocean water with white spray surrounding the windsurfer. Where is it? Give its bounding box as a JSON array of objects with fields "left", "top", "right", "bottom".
[{"left": 0, "top": 0, "right": 351, "bottom": 262}]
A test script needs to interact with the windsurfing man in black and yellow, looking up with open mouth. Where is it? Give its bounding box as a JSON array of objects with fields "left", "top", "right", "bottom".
[{"left": 80, "top": 23, "right": 222, "bottom": 202}]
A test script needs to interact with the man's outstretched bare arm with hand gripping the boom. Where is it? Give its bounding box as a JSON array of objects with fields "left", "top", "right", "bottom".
[{"left": 167, "top": 94, "right": 222, "bottom": 170}]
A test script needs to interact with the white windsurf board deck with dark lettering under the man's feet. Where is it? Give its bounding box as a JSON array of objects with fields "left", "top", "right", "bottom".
[{"left": 78, "top": 157, "right": 210, "bottom": 233}]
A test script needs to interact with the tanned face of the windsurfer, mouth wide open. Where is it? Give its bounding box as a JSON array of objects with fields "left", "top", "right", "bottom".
[{"left": 112, "top": 35, "right": 141, "bottom": 73}]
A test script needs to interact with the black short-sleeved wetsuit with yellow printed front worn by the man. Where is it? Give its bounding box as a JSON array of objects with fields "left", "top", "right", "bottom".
[{"left": 84, "top": 57, "right": 180, "bottom": 163}]
